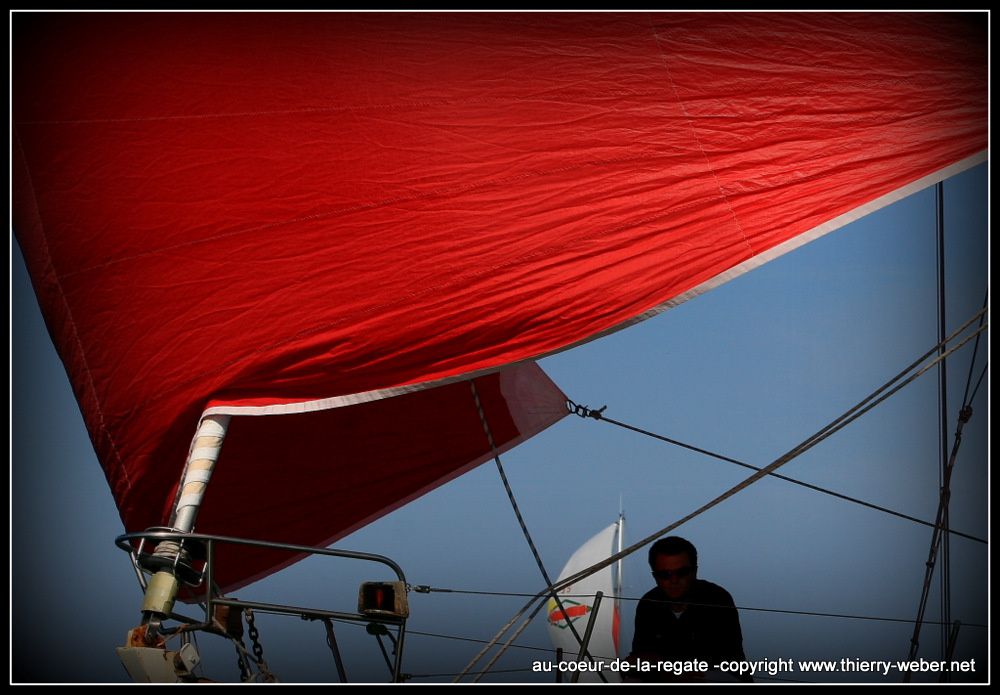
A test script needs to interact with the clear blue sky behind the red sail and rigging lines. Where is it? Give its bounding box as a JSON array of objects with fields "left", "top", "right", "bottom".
[{"left": 10, "top": 159, "right": 989, "bottom": 683}]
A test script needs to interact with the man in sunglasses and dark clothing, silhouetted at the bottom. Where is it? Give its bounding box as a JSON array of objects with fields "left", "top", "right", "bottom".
[{"left": 629, "top": 536, "right": 750, "bottom": 681}]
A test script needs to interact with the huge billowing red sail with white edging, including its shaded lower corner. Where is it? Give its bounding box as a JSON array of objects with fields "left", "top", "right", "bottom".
[{"left": 12, "top": 13, "right": 987, "bottom": 586}]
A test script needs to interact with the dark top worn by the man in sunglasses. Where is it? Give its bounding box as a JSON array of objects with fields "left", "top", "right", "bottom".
[{"left": 631, "top": 579, "right": 746, "bottom": 680}]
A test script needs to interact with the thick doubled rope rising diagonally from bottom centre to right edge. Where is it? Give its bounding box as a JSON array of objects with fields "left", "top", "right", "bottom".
[{"left": 460, "top": 308, "right": 989, "bottom": 677}]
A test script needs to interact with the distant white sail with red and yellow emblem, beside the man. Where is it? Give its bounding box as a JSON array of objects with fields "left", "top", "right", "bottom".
[{"left": 547, "top": 518, "right": 624, "bottom": 683}]
